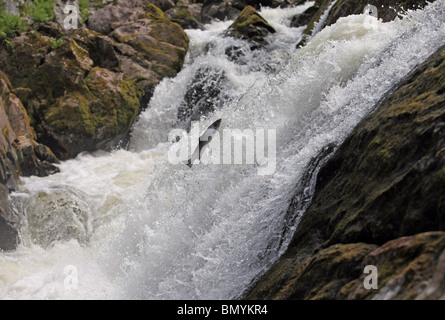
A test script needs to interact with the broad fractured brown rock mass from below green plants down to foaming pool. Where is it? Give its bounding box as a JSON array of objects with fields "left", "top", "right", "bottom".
[{"left": 0, "top": 29, "right": 142, "bottom": 159}]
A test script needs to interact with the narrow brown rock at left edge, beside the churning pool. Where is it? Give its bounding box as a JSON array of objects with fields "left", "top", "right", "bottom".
[{"left": 0, "top": 71, "right": 58, "bottom": 251}]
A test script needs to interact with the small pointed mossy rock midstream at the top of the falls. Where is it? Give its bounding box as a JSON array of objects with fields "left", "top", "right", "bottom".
[{"left": 226, "top": 6, "right": 276, "bottom": 47}]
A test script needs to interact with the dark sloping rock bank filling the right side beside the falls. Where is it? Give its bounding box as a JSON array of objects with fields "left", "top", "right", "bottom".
[{"left": 245, "top": 47, "right": 445, "bottom": 299}]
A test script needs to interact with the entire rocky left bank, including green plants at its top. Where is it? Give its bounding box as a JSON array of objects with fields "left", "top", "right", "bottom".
[{"left": 0, "top": 0, "right": 188, "bottom": 249}]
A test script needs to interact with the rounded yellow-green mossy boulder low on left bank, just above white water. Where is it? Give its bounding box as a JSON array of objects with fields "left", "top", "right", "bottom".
[{"left": 42, "top": 67, "right": 142, "bottom": 159}]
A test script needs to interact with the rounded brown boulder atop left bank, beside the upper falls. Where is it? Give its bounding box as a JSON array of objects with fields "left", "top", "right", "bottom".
[{"left": 88, "top": 0, "right": 189, "bottom": 107}]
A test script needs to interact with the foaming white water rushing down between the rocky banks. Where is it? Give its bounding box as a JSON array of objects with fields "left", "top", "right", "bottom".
[{"left": 0, "top": 1, "right": 445, "bottom": 299}]
